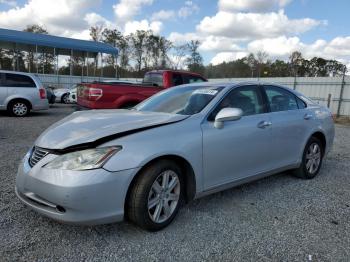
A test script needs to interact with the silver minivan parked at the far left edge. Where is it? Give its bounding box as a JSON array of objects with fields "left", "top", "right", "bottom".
[{"left": 0, "top": 70, "right": 49, "bottom": 116}]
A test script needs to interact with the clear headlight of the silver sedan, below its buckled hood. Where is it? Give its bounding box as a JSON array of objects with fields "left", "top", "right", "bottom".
[{"left": 44, "top": 146, "right": 122, "bottom": 170}]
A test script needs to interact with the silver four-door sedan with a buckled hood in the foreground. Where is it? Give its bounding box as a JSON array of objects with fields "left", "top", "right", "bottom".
[{"left": 16, "top": 82, "right": 334, "bottom": 231}]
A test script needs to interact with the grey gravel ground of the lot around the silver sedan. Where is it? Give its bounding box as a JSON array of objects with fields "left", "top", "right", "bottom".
[{"left": 0, "top": 105, "right": 350, "bottom": 261}]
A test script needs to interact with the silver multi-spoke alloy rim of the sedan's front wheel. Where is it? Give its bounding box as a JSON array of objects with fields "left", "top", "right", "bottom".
[{"left": 147, "top": 170, "right": 181, "bottom": 223}]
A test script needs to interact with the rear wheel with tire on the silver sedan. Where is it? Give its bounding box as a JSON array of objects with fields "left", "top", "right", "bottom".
[{"left": 293, "top": 137, "right": 324, "bottom": 179}]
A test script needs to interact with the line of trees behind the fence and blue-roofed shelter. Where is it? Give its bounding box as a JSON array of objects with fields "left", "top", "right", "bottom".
[{"left": 0, "top": 25, "right": 346, "bottom": 78}]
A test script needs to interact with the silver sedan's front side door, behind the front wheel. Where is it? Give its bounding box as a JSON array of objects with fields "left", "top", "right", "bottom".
[{"left": 201, "top": 85, "right": 273, "bottom": 190}]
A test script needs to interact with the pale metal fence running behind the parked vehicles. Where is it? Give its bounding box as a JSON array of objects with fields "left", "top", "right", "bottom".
[{"left": 38, "top": 74, "right": 350, "bottom": 116}]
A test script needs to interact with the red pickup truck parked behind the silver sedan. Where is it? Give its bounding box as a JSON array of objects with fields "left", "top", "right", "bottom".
[{"left": 77, "top": 70, "right": 207, "bottom": 109}]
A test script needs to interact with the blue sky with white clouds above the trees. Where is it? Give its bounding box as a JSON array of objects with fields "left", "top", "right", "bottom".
[{"left": 0, "top": 0, "right": 350, "bottom": 68}]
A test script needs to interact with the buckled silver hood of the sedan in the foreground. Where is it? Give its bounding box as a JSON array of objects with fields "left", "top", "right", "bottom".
[{"left": 35, "top": 109, "right": 188, "bottom": 151}]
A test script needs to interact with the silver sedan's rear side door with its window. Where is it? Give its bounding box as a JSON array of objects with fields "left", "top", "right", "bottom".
[{"left": 264, "top": 85, "right": 313, "bottom": 168}]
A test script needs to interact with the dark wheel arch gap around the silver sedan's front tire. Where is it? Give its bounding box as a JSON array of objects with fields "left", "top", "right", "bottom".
[{"left": 124, "top": 154, "right": 196, "bottom": 214}]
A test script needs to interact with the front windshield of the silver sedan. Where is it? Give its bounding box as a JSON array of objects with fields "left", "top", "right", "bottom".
[{"left": 135, "top": 86, "right": 224, "bottom": 115}]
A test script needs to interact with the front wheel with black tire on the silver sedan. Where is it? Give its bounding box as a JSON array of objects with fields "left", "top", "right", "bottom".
[{"left": 127, "top": 160, "right": 184, "bottom": 231}]
